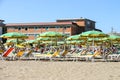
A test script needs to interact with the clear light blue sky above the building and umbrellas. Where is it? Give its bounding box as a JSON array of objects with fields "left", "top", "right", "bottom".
[{"left": 0, "top": 0, "right": 120, "bottom": 33}]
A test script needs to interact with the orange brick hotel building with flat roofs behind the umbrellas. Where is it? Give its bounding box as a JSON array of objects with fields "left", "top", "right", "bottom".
[{"left": 0, "top": 18, "right": 101, "bottom": 39}]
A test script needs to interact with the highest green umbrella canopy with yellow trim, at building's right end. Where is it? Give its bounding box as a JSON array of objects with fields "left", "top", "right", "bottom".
[{"left": 81, "top": 30, "right": 108, "bottom": 37}]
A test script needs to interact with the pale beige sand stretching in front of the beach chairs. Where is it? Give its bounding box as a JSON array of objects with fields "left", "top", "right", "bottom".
[{"left": 0, "top": 61, "right": 120, "bottom": 80}]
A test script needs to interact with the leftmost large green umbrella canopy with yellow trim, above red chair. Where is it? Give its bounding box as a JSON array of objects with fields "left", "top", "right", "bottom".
[{"left": 0, "top": 32, "right": 28, "bottom": 39}]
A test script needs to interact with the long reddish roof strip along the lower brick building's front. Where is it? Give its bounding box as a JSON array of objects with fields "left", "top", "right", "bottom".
[{"left": 6, "top": 22, "right": 72, "bottom": 26}]
